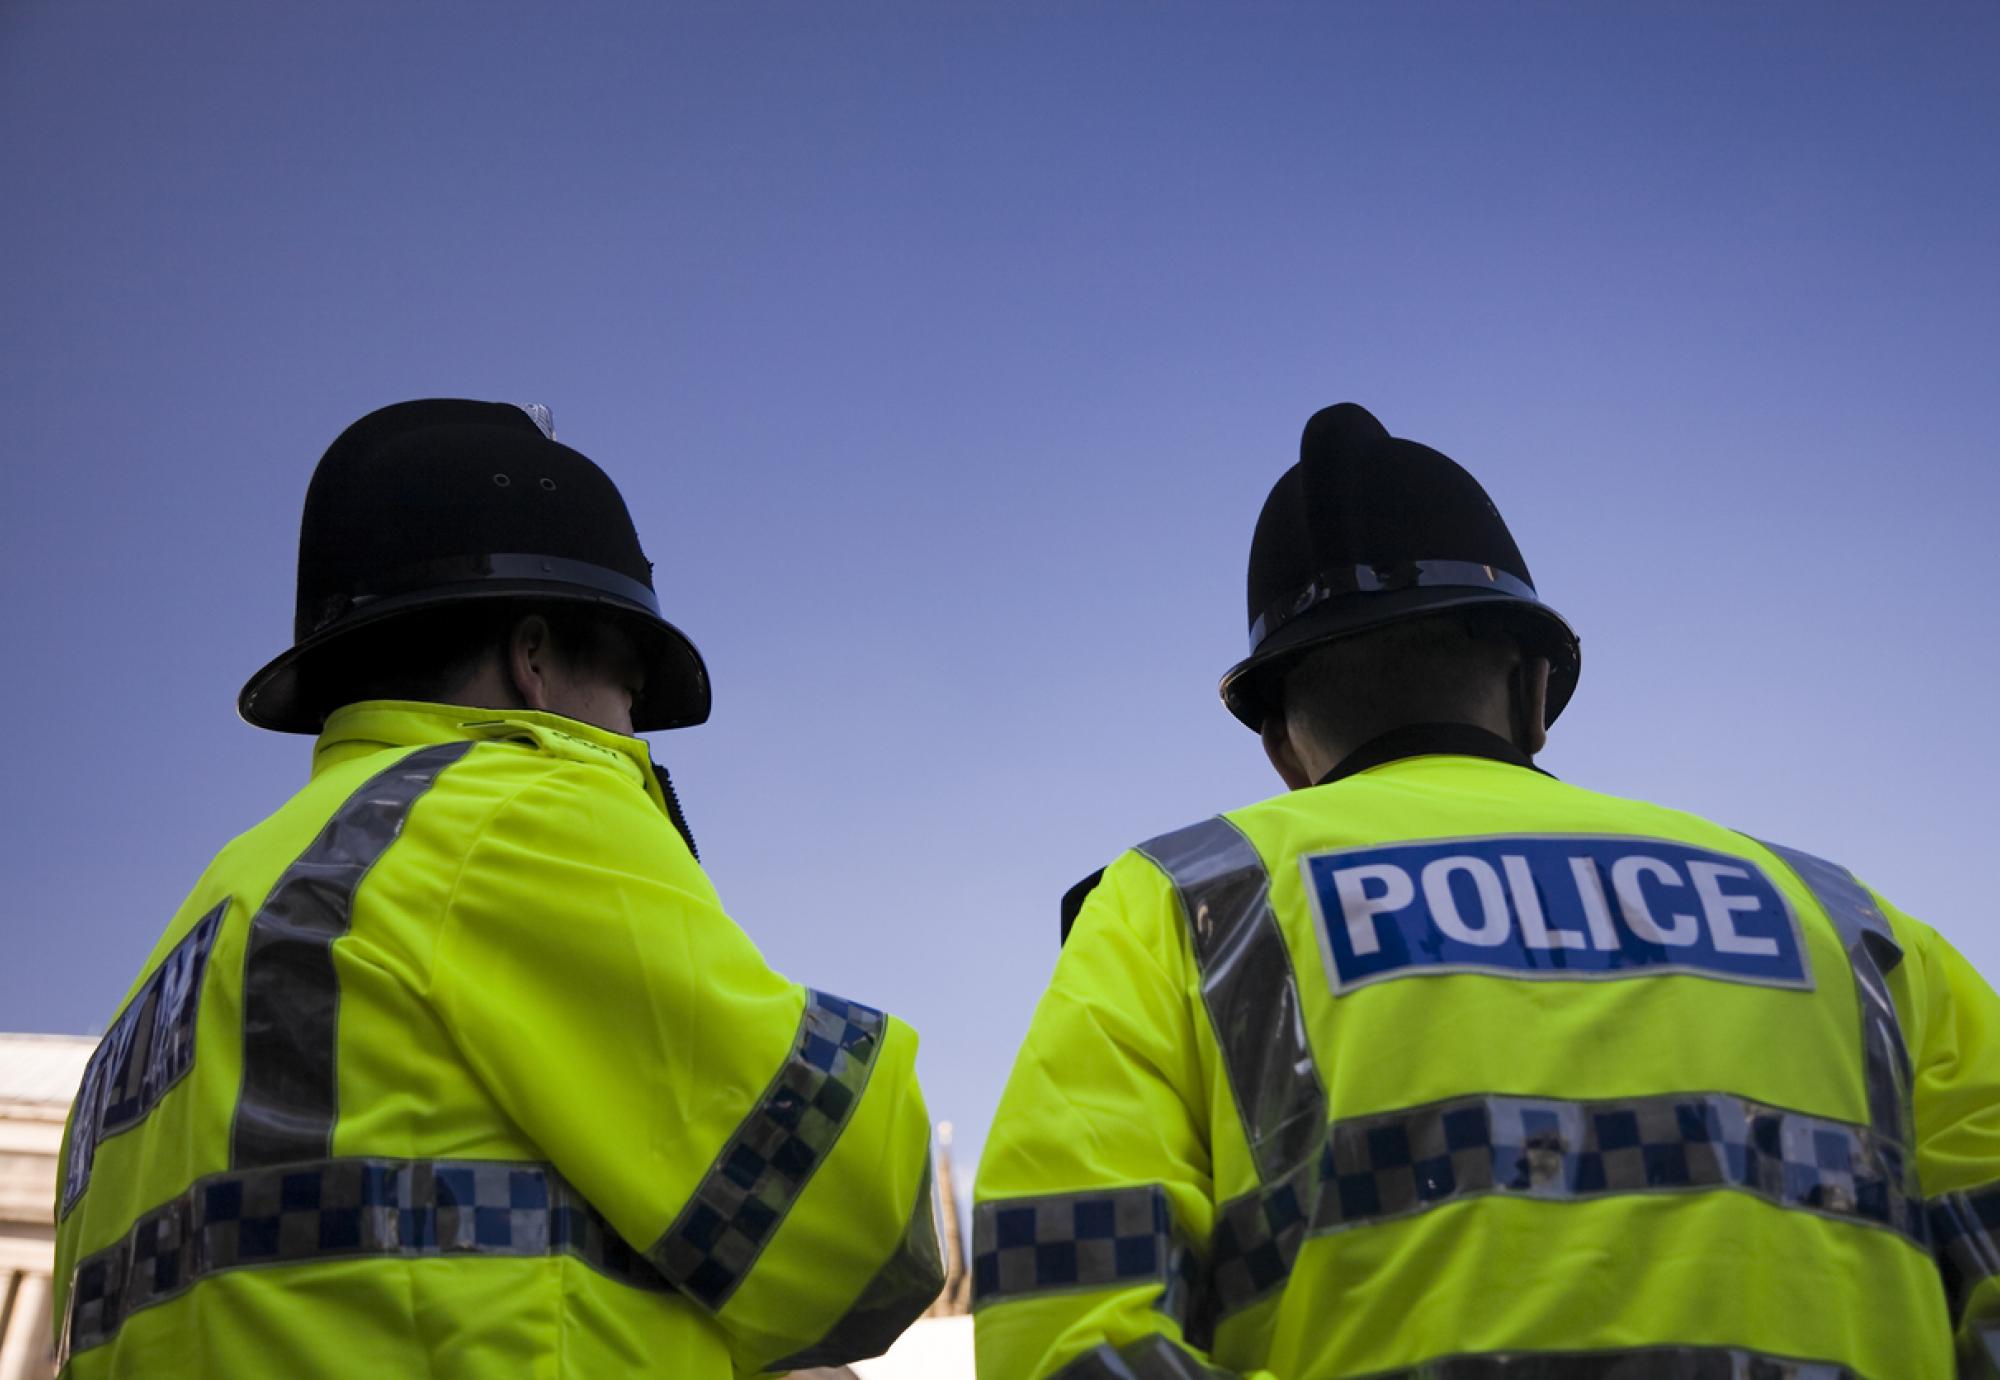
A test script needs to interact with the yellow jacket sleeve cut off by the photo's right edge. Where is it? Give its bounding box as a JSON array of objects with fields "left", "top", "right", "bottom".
[{"left": 1906, "top": 908, "right": 2000, "bottom": 1376}]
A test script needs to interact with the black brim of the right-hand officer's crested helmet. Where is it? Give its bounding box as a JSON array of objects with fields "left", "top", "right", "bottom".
[{"left": 1220, "top": 586, "right": 1582, "bottom": 732}]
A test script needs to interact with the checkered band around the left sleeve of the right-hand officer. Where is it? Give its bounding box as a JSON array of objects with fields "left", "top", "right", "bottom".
[{"left": 972, "top": 1184, "right": 1202, "bottom": 1334}]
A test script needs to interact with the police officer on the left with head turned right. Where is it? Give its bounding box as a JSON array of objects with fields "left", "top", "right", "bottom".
[{"left": 56, "top": 400, "right": 942, "bottom": 1380}]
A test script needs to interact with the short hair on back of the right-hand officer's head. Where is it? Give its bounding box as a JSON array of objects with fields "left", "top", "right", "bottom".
[{"left": 1282, "top": 610, "right": 1522, "bottom": 746}]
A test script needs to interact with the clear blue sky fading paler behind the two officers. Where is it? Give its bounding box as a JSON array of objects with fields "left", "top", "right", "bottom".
[{"left": 0, "top": 0, "right": 2000, "bottom": 1164}]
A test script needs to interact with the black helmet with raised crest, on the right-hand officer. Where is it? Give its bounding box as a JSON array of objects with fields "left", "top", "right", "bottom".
[{"left": 1222, "top": 402, "right": 1582, "bottom": 730}]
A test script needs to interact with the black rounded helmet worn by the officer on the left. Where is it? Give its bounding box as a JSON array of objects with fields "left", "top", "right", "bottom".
[{"left": 236, "top": 398, "right": 710, "bottom": 734}]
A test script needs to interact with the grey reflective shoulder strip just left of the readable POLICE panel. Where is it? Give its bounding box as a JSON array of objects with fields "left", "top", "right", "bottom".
[{"left": 1138, "top": 816, "right": 1326, "bottom": 1180}]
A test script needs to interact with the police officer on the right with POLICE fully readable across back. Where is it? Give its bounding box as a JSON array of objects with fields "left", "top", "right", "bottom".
[{"left": 974, "top": 404, "right": 2000, "bottom": 1380}]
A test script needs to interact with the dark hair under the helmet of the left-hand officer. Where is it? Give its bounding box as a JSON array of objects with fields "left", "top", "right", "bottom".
[{"left": 326, "top": 600, "right": 612, "bottom": 710}]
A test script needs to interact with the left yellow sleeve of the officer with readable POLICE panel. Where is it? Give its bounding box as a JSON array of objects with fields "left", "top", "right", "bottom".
[{"left": 972, "top": 854, "right": 1280, "bottom": 1380}]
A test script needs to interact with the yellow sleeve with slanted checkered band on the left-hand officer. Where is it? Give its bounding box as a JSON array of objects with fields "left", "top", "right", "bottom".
[{"left": 432, "top": 764, "right": 944, "bottom": 1372}]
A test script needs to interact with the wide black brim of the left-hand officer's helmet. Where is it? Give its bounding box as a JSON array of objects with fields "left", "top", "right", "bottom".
[{"left": 236, "top": 580, "right": 712, "bottom": 734}]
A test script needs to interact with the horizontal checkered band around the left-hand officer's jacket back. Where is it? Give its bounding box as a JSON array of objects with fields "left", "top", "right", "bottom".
[{"left": 58, "top": 1158, "right": 666, "bottom": 1366}]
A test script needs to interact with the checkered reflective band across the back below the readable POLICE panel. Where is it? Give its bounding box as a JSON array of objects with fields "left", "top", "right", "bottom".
[{"left": 1208, "top": 1092, "right": 1928, "bottom": 1316}]
